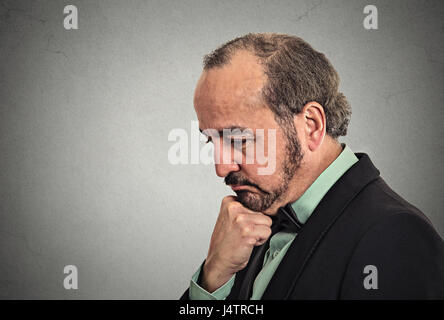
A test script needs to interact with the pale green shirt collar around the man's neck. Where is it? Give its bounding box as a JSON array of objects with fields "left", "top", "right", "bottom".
[{"left": 291, "top": 143, "right": 358, "bottom": 223}]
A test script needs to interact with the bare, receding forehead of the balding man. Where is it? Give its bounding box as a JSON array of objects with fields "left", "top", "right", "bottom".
[{"left": 194, "top": 51, "right": 272, "bottom": 129}]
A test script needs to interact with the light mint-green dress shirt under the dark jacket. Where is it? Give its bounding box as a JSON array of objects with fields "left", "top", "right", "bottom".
[{"left": 189, "top": 144, "right": 358, "bottom": 300}]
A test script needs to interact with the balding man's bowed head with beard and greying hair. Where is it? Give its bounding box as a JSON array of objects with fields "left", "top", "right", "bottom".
[{"left": 194, "top": 34, "right": 351, "bottom": 214}]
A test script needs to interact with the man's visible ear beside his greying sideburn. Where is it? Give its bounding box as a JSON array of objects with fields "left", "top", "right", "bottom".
[{"left": 301, "top": 101, "right": 326, "bottom": 151}]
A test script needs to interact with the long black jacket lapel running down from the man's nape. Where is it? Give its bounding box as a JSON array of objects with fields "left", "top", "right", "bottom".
[{"left": 262, "top": 153, "right": 379, "bottom": 299}]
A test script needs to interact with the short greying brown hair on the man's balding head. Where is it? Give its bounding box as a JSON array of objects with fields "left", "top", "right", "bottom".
[{"left": 203, "top": 33, "right": 351, "bottom": 139}]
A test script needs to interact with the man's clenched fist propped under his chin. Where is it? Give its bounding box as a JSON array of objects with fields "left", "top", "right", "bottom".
[{"left": 202, "top": 196, "right": 272, "bottom": 292}]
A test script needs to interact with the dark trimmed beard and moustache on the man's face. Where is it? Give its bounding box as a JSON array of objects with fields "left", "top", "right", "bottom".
[{"left": 225, "top": 124, "right": 303, "bottom": 212}]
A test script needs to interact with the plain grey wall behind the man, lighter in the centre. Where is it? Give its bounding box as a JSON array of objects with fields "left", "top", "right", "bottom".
[{"left": 0, "top": 0, "right": 444, "bottom": 299}]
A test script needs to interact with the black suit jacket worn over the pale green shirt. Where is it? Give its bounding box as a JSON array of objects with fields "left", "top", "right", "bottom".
[{"left": 181, "top": 153, "right": 444, "bottom": 300}]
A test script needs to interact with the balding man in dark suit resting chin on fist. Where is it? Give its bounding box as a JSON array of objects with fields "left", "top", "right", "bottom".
[{"left": 182, "top": 34, "right": 444, "bottom": 299}]
